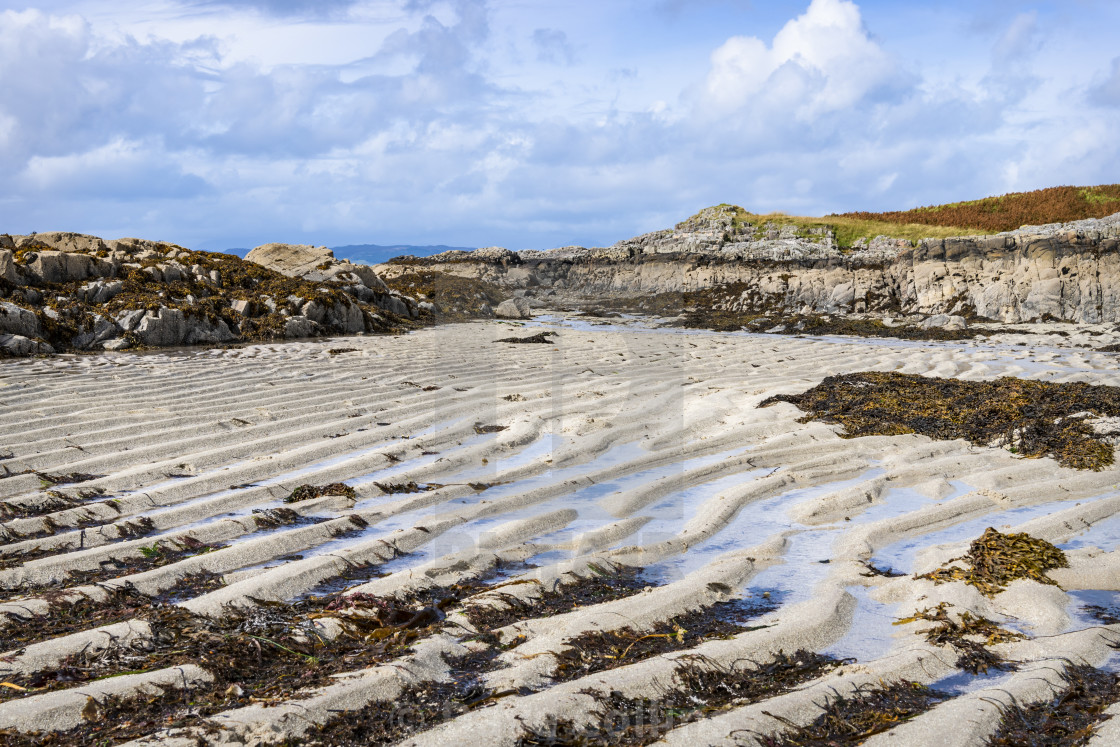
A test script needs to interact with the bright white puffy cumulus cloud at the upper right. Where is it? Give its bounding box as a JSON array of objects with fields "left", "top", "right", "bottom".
[{"left": 704, "top": 0, "right": 896, "bottom": 119}]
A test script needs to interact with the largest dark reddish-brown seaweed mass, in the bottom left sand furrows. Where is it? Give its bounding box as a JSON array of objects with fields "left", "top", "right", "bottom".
[{"left": 0, "top": 579, "right": 495, "bottom": 745}]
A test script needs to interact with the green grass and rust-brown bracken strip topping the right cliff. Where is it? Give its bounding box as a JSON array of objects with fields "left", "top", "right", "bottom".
[{"left": 682, "top": 185, "right": 1120, "bottom": 246}]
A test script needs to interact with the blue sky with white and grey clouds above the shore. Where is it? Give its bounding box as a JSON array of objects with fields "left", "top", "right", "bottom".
[{"left": 0, "top": 0, "right": 1120, "bottom": 250}]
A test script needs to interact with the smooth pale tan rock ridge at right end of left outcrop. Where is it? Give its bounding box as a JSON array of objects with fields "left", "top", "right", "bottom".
[{"left": 245, "top": 244, "right": 420, "bottom": 319}]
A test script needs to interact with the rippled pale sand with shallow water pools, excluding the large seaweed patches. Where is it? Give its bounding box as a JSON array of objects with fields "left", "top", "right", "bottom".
[{"left": 0, "top": 315, "right": 1120, "bottom": 745}]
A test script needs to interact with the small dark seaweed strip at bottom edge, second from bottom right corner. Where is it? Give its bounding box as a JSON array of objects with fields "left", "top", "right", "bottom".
[{"left": 760, "top": 682, "right": 948, "bottom": 747}]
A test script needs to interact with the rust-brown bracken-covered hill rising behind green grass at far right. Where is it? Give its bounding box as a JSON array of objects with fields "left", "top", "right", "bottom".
[{"left": 828, "top": 184, "right": 1120, "bottom": 232}]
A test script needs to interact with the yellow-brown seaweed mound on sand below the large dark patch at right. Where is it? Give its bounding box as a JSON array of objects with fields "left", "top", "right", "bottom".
[{"left": 918, "top": 526, "right": 1070, "bottom": 597}]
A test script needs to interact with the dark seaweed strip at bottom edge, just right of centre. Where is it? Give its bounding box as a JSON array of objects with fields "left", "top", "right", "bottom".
[{"left": 517, "top": 650, "right": 841, "bottom": 747}]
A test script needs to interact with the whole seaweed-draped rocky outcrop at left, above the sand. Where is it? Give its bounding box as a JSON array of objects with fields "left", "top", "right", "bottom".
[{"left": 0, "top": 233, "right": 417, "bottom": 355}]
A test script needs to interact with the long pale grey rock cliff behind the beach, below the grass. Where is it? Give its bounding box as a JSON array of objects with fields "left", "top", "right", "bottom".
[{"left": 377, "top": 209, "right": 1120, "bottom": 323}]
